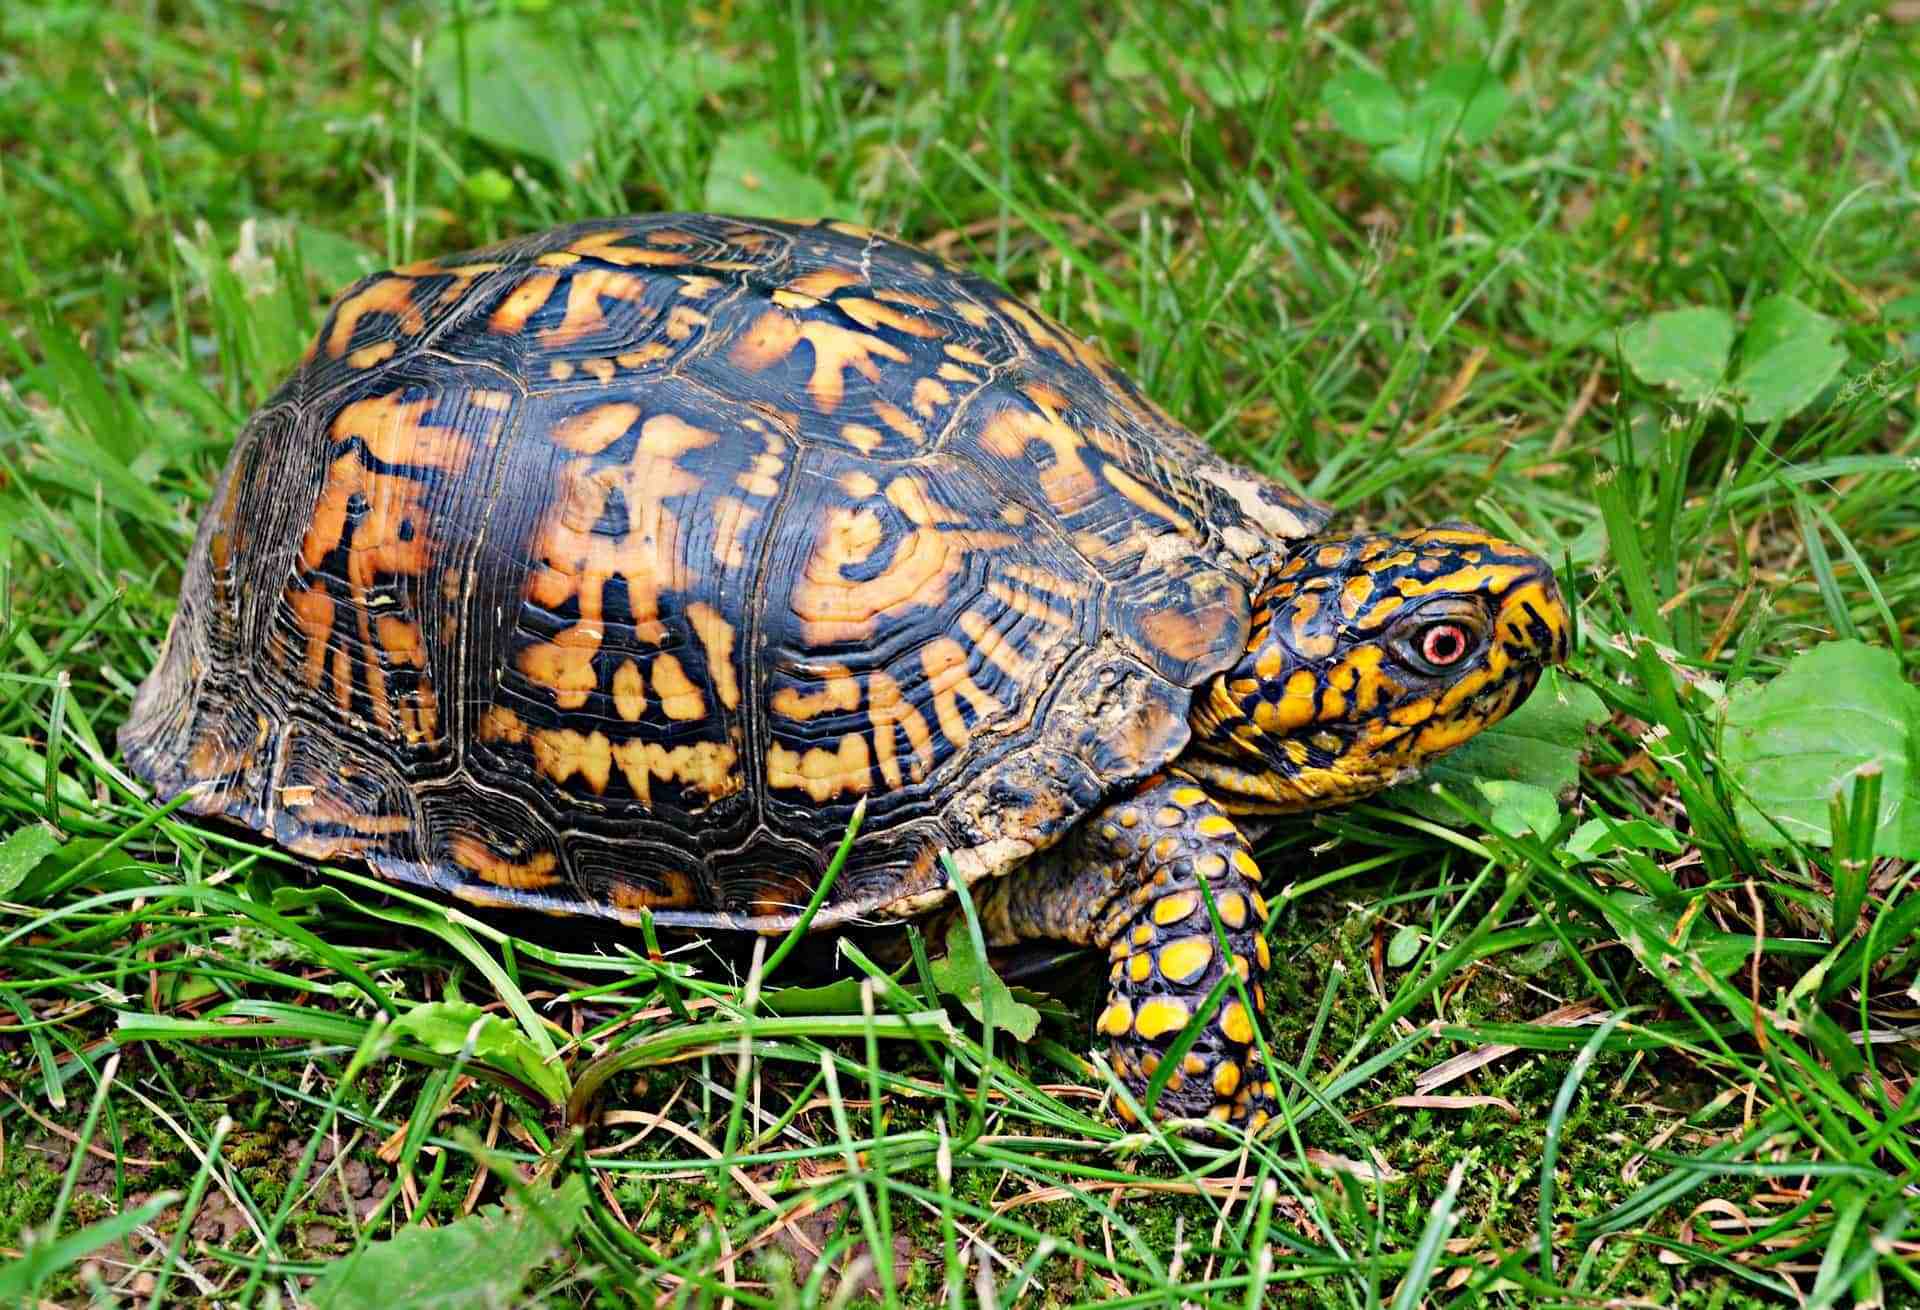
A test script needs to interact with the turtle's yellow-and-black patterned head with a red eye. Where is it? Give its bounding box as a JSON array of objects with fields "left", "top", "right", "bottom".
[{"left": 1181, "top": 524, "right": 1571, "bottom": 813}]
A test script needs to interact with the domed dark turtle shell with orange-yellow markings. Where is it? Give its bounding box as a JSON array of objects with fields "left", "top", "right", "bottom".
[{"left": 121, "top": 215, "right": 1325, "bottom": 932}]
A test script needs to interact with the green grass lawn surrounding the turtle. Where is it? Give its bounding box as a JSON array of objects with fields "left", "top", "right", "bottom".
[{"left": 0, "top": 0, "right": 1920, "bottom": 1310}]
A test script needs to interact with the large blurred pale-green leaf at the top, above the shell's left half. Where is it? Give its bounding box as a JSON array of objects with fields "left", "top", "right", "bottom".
[{"left": 420, "top": 15, "right": 593, "bottom": 173}]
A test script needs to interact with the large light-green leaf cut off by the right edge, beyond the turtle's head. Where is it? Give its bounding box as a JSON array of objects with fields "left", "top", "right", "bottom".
[{"left": 1720, "top": 642, "right": 1920, "bottom": 859}]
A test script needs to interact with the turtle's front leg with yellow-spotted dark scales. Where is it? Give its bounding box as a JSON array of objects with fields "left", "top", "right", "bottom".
[{"left": 983, "top": 778, "right": 1275, "bottom": 1129}]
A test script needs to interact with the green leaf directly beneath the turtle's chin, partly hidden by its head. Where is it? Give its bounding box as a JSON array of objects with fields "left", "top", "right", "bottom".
[{"left": 1386, "top": 668, "right": 1607, "bottom": 824}]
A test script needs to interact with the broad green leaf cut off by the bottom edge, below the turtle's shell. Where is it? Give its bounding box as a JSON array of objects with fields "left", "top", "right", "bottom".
[{"left": 305, "top": 1177, "right": 588, "bottom": 1310}]
